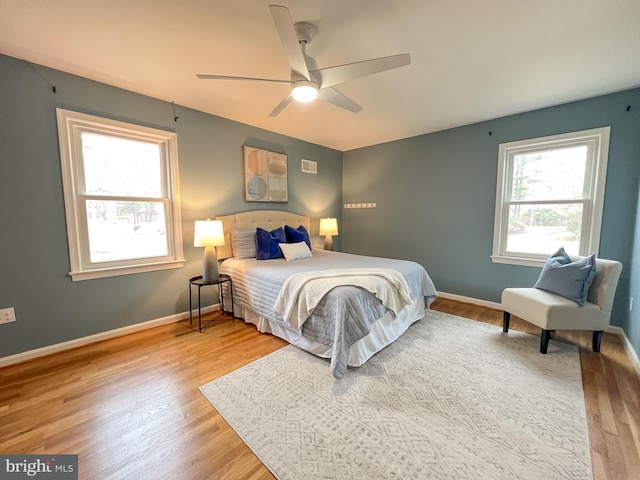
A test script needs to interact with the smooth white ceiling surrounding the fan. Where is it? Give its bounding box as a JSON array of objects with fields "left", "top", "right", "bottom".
[{"left": 0, "top": 0, "right": 640, "bottom": 151}]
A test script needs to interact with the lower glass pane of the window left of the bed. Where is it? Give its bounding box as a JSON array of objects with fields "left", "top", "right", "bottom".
[{"left": 87, "top": 200, "right": 168, "bottom": 263}]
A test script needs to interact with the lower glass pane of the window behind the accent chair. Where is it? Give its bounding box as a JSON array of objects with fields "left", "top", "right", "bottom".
[{"left": 507, "top": 204, "right": 583, "bottom": 256}]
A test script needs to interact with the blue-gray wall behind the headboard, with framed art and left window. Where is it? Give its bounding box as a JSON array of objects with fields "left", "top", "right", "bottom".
[{"left": 0, "top": 55, "right": 342, "bottom": 357}]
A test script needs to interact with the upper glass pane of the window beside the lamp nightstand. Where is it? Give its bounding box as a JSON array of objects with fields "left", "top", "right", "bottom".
[{"left": 81, "top": 132, "right": 163, "bottom": 198}]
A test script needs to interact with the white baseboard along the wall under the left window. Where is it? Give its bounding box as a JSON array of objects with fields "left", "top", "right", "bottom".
[{"left": 0, "top": 303, "right": 220, "bottom": 367}]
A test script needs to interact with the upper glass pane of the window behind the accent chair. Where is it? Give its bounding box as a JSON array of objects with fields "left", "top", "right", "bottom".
[{"left": 511, "top": 145, "right": 587, "bottom": 201}]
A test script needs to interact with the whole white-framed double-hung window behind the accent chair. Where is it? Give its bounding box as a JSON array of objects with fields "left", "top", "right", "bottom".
[{"left": 491, "top": 127, "right": 610, "bottom": 265}]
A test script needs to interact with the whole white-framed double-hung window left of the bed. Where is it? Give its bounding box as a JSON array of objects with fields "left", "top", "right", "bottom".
[{"left": 57, "top": 109, "right": 184, "bottom": 280}]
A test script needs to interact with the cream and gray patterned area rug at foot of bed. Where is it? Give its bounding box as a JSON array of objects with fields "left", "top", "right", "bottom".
[{"left": 200, "top": 311, "right": 592, "bottom": 480}]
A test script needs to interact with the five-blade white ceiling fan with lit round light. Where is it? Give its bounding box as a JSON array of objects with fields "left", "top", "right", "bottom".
[{"left": 196, "top": 5, "right": 411, "bottom": 117}]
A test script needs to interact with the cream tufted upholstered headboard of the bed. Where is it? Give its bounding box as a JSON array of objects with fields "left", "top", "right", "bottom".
[{"left": 215, "top": 210, "right": 310, "bottom": 260}]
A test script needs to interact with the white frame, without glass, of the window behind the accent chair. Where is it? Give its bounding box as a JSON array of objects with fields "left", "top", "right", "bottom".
[{"left": 491, "top": 127, "right": 611, "bottom": 266}]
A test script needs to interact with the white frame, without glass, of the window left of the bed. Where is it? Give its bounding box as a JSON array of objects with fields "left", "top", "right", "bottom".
[{"left": 56, "top": 108, "right": 185, "bottom": 281}]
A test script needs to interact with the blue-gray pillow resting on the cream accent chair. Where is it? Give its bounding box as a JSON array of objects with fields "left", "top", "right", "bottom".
[{"left": 534, "top": 248, "right": 596, "bottom": 306}]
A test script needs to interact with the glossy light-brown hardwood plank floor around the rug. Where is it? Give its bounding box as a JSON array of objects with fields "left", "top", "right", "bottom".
[{"left": 0, "top": 299, "right": 640, "bottom": 480}]
